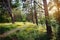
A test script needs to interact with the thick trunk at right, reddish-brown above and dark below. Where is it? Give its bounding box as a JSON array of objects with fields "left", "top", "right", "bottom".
[{"left": 43, "top": 0, "right": 52, "bottom": 40}]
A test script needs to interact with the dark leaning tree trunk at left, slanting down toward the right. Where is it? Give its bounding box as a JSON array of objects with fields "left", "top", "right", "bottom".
[{"left": 2, "top": 0, "right": 14, "bottom": 23}]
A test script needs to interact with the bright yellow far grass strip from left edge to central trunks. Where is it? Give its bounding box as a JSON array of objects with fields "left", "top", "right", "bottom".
[{"left": 0, "top": 22, "right": 36, "bottom": 27}]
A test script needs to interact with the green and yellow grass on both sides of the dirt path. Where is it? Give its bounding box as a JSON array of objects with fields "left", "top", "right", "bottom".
[{"left": 0, "top": 22, "right": 47, "bottom": 40}]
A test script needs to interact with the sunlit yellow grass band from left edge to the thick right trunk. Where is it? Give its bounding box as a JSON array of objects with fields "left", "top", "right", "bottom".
[{"left": 0, "top": 22, "right": 46, "bottom": 33}]
